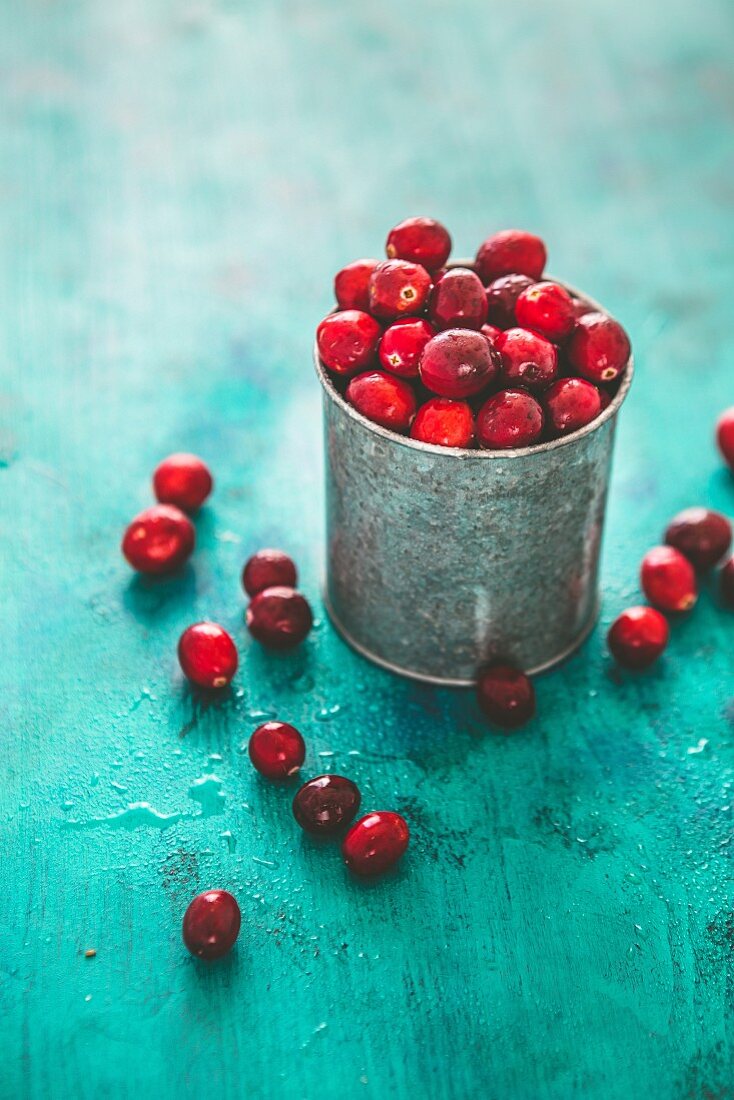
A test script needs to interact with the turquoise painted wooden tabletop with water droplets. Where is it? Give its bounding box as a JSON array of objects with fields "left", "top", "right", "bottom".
[{"left": 0, "top": 0, "right": 734, "bottom": 1100}]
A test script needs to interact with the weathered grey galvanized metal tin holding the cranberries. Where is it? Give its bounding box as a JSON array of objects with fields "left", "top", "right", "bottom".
[{"left": 315, "top": 288, "right": 633, "bottom": 686}]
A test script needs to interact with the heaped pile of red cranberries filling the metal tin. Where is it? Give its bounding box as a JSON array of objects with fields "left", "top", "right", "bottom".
[{"left": 316, "top": 218, "right": 631, "bottom": 450}]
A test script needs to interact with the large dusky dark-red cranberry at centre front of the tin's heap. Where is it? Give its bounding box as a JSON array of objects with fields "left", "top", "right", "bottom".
[{"left": 420, "top": 329, "right": 500, "bottom": 397}]
